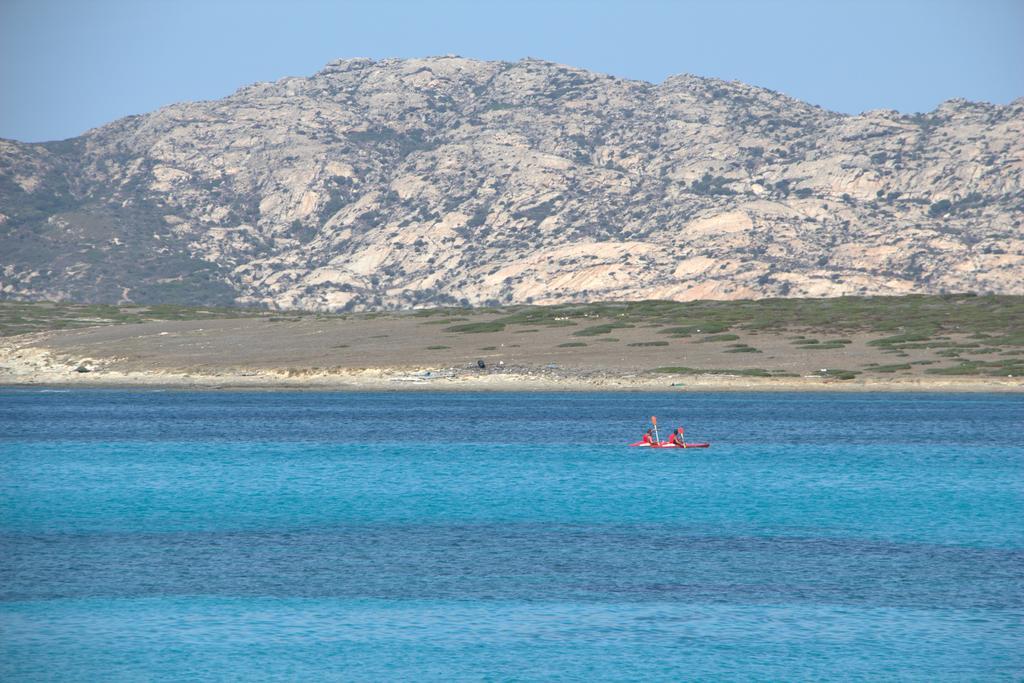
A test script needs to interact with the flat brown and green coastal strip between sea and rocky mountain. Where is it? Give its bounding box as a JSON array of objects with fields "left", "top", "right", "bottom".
[{"left": 0, "top": 296, "right": 1024, "bottom": 391}]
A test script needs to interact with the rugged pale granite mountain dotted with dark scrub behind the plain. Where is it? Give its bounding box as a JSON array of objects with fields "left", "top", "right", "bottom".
[{"left": 0, "top": 57, "right": 1024, "bottom": 310}]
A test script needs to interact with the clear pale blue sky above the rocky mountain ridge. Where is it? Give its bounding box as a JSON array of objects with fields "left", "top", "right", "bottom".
[{"left": 0, "top": 0, "right": 1024, "bottom": 141}]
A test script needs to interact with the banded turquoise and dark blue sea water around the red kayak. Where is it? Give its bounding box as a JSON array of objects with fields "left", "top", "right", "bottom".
[{"left": 0, "top": 390, "right": 1024, "bottom": 680}]
